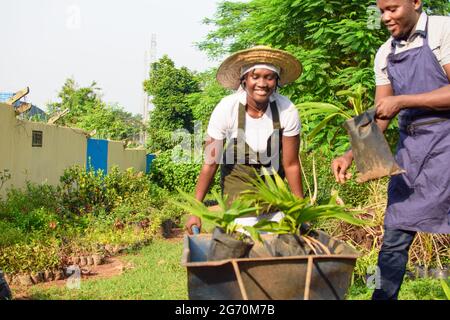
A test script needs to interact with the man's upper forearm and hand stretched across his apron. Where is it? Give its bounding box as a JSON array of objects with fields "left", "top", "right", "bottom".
[{"left": 376, "top": 64, "right": 450, "bottom": 119}]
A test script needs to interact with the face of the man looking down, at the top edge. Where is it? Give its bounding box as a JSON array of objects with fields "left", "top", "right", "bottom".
[{"left": 377, "top": 0, "right": 421, "bottom": 39}]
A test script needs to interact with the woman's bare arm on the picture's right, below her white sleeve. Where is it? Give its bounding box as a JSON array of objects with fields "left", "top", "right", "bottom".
[{"left": 282, "top": 135, "right": 304, "bottom": 198}]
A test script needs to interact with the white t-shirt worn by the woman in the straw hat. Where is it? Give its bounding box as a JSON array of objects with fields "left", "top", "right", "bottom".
[{"left": 207, "top": 90, "right": 301, "bottom": 152}]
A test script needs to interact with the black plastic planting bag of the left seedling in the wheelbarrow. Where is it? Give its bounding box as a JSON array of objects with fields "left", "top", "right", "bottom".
[{"left": 207, "top": 227, "right": 254, "bottom": 261}]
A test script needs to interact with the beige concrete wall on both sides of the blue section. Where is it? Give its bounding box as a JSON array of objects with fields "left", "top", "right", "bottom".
[{"left": 0, "top": 104, "right": 150, "bottom": 196}]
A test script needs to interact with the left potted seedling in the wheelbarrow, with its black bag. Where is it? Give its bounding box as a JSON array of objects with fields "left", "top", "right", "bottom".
[{"left": 173, "top": 190, "right": 258, "bottom": 261}]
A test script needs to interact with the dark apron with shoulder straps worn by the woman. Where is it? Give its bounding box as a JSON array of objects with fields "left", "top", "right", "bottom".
[{"left": 221, "top": 101, "right": 284, "bottom": 202}]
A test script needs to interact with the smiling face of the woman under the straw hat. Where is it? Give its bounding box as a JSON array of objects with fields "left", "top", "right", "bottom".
[{"left": 244, "top": 69, "right": 278, "bottom": 103}]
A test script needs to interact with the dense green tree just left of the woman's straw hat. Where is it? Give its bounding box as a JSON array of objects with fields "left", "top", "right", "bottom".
[{"left": 144, "top": 55, "right": 200, "bottom": 151}]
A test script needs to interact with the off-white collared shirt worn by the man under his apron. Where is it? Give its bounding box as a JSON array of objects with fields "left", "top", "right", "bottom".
[{"left": 374, "top": 12, "right": 450, "bottom": 86}]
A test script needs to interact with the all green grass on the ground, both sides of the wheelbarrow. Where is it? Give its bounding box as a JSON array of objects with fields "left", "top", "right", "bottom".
[{"left": 21, "top": 235, "right": 446, "bottom": 300}]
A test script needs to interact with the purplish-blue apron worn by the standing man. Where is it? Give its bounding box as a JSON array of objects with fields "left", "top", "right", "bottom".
[{"left": 385, "top": 19, "right": 450, "bottom": 233}]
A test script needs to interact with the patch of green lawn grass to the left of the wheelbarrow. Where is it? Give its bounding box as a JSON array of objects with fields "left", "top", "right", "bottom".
[{"left": 26, "top": 239, "right": 187, "bottom": 300}]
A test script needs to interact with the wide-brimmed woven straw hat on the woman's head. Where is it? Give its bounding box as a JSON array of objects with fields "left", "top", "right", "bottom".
[{"left": 216, "top": 46, "right": 303, "bottom": 90}]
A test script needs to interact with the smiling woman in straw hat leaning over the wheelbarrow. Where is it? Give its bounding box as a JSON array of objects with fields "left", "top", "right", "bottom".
[{"left": 186, "top": 46, "right": 303, "bottom": 234}]
